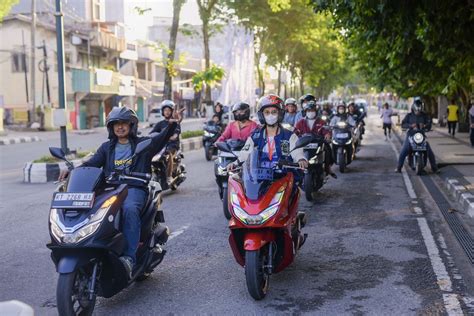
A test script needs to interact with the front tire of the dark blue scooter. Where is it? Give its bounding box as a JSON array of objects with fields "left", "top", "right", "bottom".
[{"left": 56, "top": 270, "right": 96, "bottom": 316}]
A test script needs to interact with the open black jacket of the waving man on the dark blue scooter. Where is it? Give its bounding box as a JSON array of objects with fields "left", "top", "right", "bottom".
[{"left": 81, "top": 123, "right": 178, "bottom": 187}]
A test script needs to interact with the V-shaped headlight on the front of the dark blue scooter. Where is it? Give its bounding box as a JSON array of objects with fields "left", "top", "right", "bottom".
[{"left": 49, "top": 195, "right": 117, "bottom": 244}]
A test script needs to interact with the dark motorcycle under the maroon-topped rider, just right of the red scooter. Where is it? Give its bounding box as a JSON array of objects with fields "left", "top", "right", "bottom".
[{"left": 303, "top": 134, "right": 327, "bottom": 201}]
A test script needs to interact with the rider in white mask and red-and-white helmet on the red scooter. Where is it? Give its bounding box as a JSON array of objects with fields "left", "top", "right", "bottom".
[{"left": 228, "top": 94, "right": 308, "bottom": 178}]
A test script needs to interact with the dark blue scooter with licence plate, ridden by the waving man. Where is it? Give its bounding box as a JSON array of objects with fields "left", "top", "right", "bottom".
[{"left": 47, "top": 140, "right": 169, "bottom": 315}]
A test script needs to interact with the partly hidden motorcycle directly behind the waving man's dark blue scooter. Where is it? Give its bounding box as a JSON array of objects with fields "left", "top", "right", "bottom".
[{"left": 151, "top": 147, "right": 186, "bottom": 191}]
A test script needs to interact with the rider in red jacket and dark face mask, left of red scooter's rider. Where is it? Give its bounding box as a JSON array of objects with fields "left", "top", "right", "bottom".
[{"left": 217, "top": 102, "right": 258, "bottom": 142}]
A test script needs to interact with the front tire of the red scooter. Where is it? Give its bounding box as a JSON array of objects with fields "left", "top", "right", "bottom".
[{"left": 245, "top": 249, "right": 270, "bottom": 301}]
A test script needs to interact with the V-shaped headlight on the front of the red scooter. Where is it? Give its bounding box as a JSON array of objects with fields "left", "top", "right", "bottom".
[{"left": 231, "top": 187, "right": 285, "bottom": 225}]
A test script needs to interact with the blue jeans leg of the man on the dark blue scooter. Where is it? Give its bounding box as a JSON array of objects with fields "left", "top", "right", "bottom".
[{"left": 122, "top": 187, "right": 147, "bottom": 263}]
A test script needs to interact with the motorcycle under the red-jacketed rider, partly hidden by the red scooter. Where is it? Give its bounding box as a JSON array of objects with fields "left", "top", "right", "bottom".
[{"left": 214, "top": 139, "right": 245, "bottom": 219}]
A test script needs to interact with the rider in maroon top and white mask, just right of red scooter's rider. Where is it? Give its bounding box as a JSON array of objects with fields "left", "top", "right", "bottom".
[{"left": 295, "top": 101, "right": 337, "bottom": 178}]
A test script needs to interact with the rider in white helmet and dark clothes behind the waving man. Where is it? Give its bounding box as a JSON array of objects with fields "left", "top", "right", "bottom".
[{"left": 150, "top": 100, "right": 181, "bottom": 183}]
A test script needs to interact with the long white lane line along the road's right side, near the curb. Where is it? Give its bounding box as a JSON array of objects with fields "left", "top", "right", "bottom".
[{"left": 390, "top": 140, "right": 463, "bottom": 316}]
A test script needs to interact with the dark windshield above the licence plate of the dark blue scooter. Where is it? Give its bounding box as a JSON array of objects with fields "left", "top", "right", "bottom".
[{"left": 66, "top": 167, "right": 104, "bottom": 193}]
